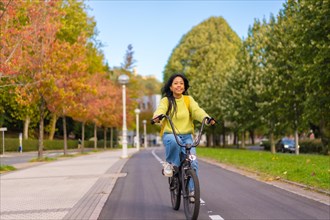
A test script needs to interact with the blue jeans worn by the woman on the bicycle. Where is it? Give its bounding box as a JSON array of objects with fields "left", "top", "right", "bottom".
[{"left": 163, "top": 133, "right": 198, "bottom": 175}]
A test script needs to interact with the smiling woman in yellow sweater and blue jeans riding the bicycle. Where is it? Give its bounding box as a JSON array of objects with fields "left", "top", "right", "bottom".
[{"left": 153, "top": 74, "right": 216, "bottom": 177}]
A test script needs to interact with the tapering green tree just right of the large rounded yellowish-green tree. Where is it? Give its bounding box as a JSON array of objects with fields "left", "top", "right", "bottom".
[{"left": 221, "top": 20, "right": 264, "bottom": 148}]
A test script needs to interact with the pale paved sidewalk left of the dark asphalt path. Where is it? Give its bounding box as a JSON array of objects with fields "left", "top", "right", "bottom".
[{"left": 0, "top": 148, "right": 136, "bottom": 220}]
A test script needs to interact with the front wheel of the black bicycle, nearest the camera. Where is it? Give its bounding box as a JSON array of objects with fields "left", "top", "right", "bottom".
[{"left": 183, "top": 169, "right": 200, "bottom": 220}]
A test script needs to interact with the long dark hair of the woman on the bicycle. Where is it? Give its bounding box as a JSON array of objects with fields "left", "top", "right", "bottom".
[{"left": 161, "top": 73, "right": 189, "bottom": 115}]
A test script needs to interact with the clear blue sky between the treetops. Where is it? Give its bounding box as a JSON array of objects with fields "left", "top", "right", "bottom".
[{"left": 86, "top": 0, "right": 285, "bottom": 82}]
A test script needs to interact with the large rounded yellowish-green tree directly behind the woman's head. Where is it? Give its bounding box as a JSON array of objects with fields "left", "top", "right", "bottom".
[{"left": 164, "top": 17, "right": 241, "bottom": 145}]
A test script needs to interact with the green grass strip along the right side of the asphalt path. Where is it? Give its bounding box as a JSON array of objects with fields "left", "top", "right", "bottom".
[{"left": 197, "top": 147, "right": 330, "bottom": 191}]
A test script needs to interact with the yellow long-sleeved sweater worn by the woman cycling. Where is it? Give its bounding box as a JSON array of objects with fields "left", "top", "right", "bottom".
[{"left": 153, "top": 96, "right": 209, "bottom": 134}]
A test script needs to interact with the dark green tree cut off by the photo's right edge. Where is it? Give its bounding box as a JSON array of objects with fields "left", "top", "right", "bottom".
[{"left": 286, "top": 0, "right": 330, "bottom": 153}]
